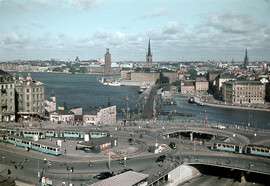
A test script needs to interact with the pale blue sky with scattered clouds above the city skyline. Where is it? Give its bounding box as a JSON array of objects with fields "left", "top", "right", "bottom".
[{"left": 0, "top": 0, "right": 270, "bottom": 62}]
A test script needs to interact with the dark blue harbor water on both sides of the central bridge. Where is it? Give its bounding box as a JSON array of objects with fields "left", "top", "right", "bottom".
[{"left": 17, "top": 72, "right": 270, "bottom": 130}]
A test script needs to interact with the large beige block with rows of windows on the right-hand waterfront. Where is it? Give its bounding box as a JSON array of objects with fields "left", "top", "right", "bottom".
[{"left": 222, "top": 81, "right": 265, "bottom": 104}]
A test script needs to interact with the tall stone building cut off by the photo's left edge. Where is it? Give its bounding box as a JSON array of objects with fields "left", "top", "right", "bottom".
[{"left": 0, "top": 70, "right": 15, "bottom": 122}]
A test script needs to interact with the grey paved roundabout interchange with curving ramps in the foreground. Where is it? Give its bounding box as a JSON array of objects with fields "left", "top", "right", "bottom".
[{"left": 0, "top": 123, "right": 270, "bottom": 185}]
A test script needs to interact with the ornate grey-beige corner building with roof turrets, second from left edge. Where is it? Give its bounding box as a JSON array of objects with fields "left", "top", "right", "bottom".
[{"left": 14, "top": 73, "right": 45, "bottom": 120}]
